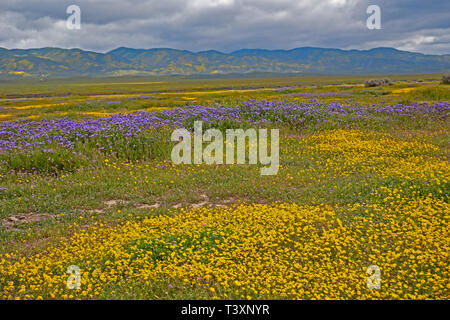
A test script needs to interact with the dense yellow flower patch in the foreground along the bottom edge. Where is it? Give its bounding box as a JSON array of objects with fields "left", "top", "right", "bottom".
[{"left": 0, "top": 198, "right": 450, "bottom": 299}]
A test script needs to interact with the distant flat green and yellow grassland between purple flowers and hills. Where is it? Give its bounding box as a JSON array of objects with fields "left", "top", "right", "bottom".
[{"left": 0, "top": 74, "right": 446, "bottom": 121}]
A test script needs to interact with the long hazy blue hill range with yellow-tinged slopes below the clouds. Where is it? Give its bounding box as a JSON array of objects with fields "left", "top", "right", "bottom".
[{"left": 0, "top": 47, "right": 450, "bottom": 78}]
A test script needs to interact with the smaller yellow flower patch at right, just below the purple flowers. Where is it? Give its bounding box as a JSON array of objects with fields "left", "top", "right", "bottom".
[{"left": 294, "top": 129, "right": 450, "bottom": 183}]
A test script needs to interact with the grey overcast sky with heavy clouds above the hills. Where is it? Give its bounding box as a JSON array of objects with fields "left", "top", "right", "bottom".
[{"left": 0, "top": 0, "right": 450, "bottom": 54}]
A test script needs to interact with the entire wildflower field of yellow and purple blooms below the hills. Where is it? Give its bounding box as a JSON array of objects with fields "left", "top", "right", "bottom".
[{"left": 0, "top": 75, "right": 450, "bottom": 299}]
